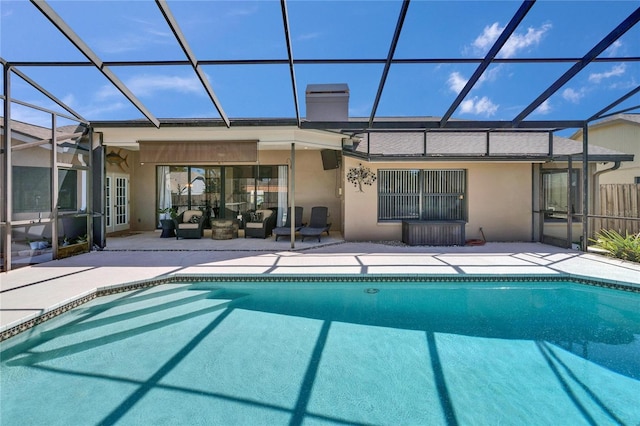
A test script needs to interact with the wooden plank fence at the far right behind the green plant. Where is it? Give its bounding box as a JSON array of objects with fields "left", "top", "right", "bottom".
[{"left": 591, "top": 184, "right": 640, "bottom": 235}]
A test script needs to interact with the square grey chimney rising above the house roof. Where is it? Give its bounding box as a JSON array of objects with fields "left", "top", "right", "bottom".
[{"left": 306, "top": 83, "right": 349, "bottom": 121}]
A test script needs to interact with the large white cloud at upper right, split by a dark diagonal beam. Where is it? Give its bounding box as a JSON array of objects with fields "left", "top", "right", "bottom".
[{"left": 472, "top": 22, "right": 551, "bottom": 58}]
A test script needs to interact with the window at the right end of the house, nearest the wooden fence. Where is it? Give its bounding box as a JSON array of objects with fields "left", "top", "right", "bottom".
[{"left": 542, "top": 169, "right": 582, "bottom": 222}]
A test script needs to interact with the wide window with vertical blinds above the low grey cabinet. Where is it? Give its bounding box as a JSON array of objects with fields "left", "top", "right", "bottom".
[{"left": 378, "top": 169, "right": 467, "bottom": 221}]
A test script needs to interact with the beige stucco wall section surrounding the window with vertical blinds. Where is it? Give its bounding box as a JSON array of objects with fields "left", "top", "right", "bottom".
[{"left": 343, "top": 157, "right": 532, "bottom": 241}]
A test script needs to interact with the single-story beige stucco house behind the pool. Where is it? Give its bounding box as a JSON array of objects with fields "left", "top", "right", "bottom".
[{"left": 3, "top": 90, "right": 634, "bottom": 270}]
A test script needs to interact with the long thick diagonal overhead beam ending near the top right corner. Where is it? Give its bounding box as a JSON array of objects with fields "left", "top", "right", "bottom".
[{"left": 513, "top": 7, "right": 640, "bottom": 126}]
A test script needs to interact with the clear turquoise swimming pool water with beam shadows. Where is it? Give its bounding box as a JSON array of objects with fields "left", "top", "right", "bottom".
[{"left": 0, "top": 281, "right": 640, "bottom": 425}]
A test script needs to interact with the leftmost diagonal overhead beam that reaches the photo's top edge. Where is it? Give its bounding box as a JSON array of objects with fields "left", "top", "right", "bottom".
[{"left": 30, "top": 0, "right": 160, "bottom": 127}]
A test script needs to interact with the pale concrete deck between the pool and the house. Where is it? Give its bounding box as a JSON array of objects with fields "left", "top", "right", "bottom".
[{"left": 0, "top": 232, "right": 640, "bottom": 338}]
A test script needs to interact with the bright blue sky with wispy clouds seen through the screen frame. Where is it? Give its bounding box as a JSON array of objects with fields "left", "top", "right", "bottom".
[{"left": 0, "top": 0, "right": 640, "bottom": 129}]
